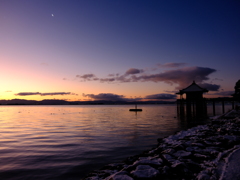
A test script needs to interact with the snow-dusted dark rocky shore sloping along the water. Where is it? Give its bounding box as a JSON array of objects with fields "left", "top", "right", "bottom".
[{"left": 84, "top": 110, "right": 240, "bottom": 180}]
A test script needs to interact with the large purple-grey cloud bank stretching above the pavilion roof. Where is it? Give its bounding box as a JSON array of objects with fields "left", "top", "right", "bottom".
[{"left": 76, "top": 63, "right": 220, "bottom": 91}]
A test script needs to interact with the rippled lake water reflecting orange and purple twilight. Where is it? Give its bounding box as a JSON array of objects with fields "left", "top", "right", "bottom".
[{"left": 0, "top": 105, "right": 230, "bottom": 180}]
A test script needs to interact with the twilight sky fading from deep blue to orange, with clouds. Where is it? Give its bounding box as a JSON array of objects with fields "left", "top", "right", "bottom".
[{"left": 0, "top": 0, "right": 240, "bottom": 101}]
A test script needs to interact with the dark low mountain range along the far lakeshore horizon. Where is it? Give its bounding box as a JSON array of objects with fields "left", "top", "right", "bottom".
[{"left": 0, "top": 99, "right": 175, "bottom": 105}]
